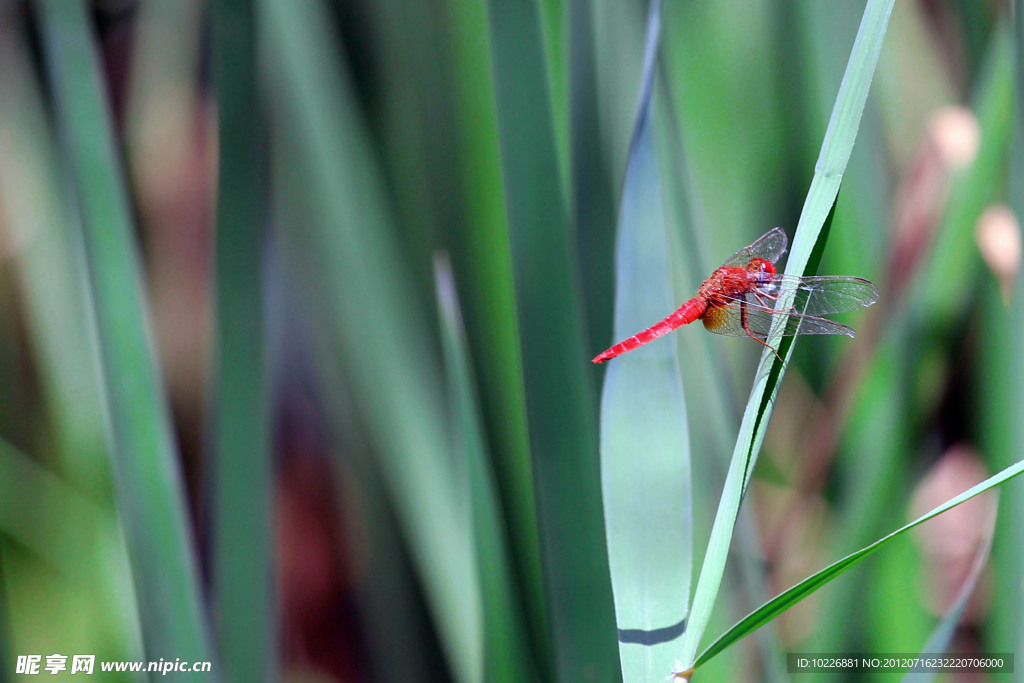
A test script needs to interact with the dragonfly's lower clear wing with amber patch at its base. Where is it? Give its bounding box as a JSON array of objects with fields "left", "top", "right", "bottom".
[{"left": 703, "top": 293, "right": 854, "bottom": 341}]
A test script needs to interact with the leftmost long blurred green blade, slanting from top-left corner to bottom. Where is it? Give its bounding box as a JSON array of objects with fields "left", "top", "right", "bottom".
[{"left": 35, "top": 0, "right": 211, "bottom": 667}]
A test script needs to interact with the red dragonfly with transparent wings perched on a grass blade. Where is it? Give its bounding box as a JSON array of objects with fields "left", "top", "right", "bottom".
[{"left": 594, "top": 227, "right": 879, "bottom": 362}]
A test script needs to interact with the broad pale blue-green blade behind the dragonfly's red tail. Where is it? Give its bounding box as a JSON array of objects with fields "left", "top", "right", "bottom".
[{"left": 601, "top": 0, "right": 693, "bottom": 682}]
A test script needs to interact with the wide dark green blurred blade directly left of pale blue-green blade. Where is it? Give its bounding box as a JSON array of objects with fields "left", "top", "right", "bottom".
[{"left": 488, "top": 0, "right": 618, "bottom": 680}]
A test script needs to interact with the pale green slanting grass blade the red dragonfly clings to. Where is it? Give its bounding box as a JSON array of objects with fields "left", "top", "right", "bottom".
[{"left": 681, "top": 0, "right": 893, "bottom": 667}]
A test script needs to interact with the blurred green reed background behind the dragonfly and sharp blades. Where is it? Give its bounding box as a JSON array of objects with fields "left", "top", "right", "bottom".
[{"left": 0, "top": 0, "right": 1024, "bottom": 681}]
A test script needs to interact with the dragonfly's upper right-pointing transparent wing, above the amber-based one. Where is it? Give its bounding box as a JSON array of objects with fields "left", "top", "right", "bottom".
[{"left": 758, "top": 273, "right": 879, "bottom": 315}]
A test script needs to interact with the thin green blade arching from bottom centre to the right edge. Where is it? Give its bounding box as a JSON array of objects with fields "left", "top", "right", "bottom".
[{"left": 693, "top": 460, "right": 1024, "bottom": 668}]
